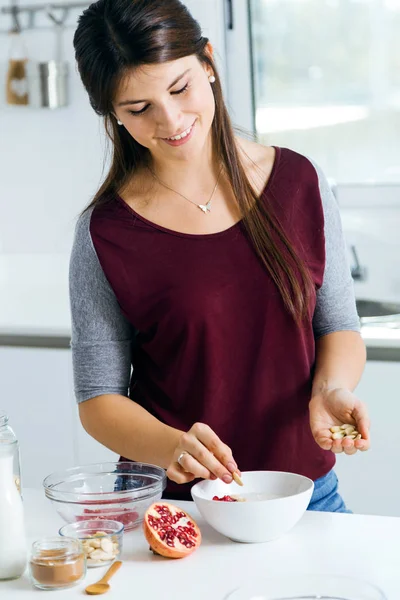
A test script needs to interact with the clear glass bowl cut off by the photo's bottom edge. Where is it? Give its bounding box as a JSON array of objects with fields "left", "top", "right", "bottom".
[{"left": 226, "top": 574, "right": 387, "bottom": 600}]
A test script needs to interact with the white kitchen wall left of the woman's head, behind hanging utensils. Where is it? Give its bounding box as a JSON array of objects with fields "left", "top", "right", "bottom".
[{"left": 0, "top": 0, "right": 102, "bottom": 254}]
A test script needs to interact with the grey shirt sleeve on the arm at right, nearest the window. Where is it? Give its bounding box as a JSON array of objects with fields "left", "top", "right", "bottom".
[{"left": 311, "top": 161, "right": 360, "bottom": 339}]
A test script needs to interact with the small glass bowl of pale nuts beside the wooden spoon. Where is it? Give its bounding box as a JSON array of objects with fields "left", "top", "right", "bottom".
[{"left": 58, "top": 519, "right": 124, "bottom": 567}]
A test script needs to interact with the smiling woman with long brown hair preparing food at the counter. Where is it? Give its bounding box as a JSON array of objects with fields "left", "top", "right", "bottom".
[{"left": 70, "top": 0, "right": 369, "bottom": 511}]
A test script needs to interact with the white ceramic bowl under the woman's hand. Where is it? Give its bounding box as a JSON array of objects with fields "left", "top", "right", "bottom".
[{"left": 191, "top": 471, "right": 314, "bottom": 542}]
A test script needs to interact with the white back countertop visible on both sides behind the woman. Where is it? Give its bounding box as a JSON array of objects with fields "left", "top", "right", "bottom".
[{"left": 0, "top": 255, "right": 400, "bottom": 346}]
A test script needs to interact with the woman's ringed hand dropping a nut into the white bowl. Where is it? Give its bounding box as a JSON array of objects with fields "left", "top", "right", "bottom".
[{"left": 167, "top": 423, "right": 240, "bottom": 483}]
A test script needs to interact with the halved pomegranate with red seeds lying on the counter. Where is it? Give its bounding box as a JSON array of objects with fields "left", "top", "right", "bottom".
[{"left": 143, "top": 502, "right": 201, "bottom": 558}]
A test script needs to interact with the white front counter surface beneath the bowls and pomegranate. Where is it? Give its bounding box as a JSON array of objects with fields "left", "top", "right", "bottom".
[{"left": 0, "top": 489, "right": 400, "bottom": 600}]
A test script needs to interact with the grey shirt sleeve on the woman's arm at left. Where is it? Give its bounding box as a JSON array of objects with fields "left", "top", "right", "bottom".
[{"left": 69, "top": 209, "right": 133, "bottom": 402}]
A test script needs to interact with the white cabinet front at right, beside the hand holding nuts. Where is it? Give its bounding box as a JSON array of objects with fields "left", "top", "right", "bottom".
[{"left": 336, "top": 361, "right": 400, "bottom": 517}]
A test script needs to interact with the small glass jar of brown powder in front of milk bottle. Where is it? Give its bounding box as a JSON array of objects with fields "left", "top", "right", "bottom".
[{"left": 29, "top": 537, "right": 86, "bottom": 590}]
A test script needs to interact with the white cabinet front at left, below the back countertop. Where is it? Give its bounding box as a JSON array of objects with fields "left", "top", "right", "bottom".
[{"left": 0, "top": 347, "right": 116, "bottom": 488}]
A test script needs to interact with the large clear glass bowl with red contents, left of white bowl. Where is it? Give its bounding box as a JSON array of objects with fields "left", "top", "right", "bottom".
[{"left": 43, "top": 462, "right": 167, "bottom": 531}]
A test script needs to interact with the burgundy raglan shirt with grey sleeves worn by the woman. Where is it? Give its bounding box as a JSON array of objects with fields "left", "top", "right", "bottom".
[{"left": 70, "top": 148, "right": 359, "bottom": 500}]
